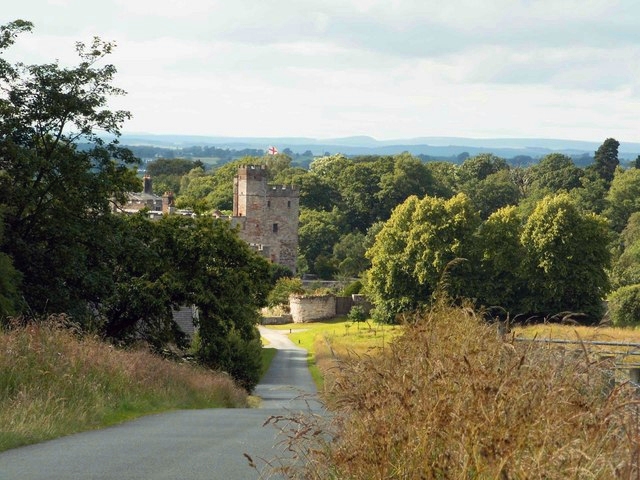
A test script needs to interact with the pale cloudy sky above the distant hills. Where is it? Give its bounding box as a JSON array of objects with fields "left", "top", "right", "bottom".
[{"left": 0, "top": 0, "right": 640, "bottom": 142}]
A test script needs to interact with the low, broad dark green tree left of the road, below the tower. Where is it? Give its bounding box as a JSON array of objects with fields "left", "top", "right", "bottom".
[{"left": 97, "top": 215, "right": 271, "bottom": 390}]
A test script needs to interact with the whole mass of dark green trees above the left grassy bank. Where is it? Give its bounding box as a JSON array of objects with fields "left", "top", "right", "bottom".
[{"left": 0, "top": 20, "right": 271, "bottom": 390}]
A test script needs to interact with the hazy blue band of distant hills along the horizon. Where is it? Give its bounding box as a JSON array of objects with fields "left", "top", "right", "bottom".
[{"left": 120, "top": 133, "right": 640, "bottom": 160}]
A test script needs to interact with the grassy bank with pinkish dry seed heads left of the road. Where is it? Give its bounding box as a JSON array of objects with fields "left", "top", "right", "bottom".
[{"left": 0, "top": 317, "right": 247, "bottom": 451}]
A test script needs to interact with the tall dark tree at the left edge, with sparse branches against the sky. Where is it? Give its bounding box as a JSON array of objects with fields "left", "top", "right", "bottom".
[{"left": 0, "top": 21, "right": 140, "bottom": 315}]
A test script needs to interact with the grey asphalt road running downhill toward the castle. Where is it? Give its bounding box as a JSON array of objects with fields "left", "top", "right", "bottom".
[{"left": 0, "top": 329, "right": 322, "bottom": 480}]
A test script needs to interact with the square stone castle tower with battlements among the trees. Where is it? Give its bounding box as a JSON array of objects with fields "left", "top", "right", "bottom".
[{"left": 233, "top": 165, "right": 300, "bottom": 273}]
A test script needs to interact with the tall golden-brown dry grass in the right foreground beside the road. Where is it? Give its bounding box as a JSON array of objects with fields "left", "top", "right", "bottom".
[{"left": 274, "top": 306, "right": 640, "bottom": 479}]
